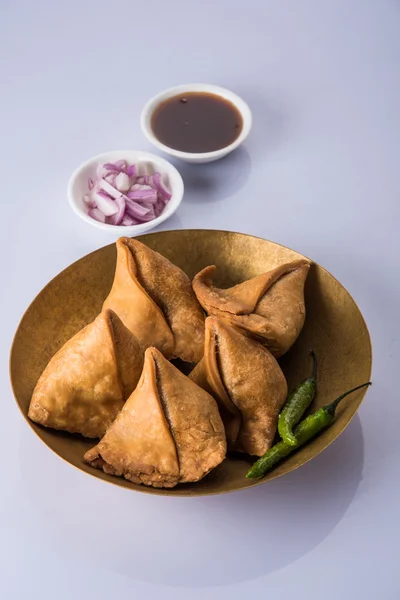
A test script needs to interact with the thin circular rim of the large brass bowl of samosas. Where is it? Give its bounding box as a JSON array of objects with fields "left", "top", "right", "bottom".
[{"left": 8, "top": 227, "right": 373, "bottom": 498}]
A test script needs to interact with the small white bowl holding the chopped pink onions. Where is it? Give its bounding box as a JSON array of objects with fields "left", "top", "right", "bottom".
[{"left": 67, "top": 150, "right": 184, "bottom": 236}]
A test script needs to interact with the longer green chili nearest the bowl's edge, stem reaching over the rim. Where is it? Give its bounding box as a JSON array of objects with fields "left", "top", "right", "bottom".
[{"left": 246, "top": 381, "right": 371, "bottom": 479}]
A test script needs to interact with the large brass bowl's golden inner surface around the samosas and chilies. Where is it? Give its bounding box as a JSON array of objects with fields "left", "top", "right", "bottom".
[{"left": 10, "top": 230, "right": 371, "bottom": 496}]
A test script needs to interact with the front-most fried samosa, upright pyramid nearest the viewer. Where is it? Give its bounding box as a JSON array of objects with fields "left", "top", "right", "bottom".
[{"left": 84, "top": 348, "right": 226, "bottom": 487}]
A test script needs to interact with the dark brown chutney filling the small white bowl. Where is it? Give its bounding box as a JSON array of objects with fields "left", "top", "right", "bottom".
[{"left": 151, "top": 92, "right": 243, "bottom": 153}]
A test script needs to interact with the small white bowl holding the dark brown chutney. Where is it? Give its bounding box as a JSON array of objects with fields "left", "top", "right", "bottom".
[{"left": 141, "top": 83, "right": 252, "bottom": 163}]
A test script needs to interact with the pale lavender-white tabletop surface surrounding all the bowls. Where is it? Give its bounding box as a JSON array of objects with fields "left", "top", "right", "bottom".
[{"left": 0, "top": 0, "right": 400, "bottom": 600}]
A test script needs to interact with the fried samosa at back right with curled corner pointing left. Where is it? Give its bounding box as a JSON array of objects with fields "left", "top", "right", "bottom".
[{"left": 193, "top": 259, "right": 310, "bottom": 357}]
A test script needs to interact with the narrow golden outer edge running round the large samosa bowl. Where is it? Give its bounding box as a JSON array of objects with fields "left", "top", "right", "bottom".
[{"left": 8, "top": 228, "right": 373, "bottom": 498}]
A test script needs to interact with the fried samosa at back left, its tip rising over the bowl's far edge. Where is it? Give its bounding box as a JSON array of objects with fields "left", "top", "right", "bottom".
[{"left": 103, "top": 237, "right": 204, "bottom": 362}]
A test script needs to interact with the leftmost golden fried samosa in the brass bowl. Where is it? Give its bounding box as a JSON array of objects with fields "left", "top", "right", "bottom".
[{"left": 28, "top": 310, "right": 144, "bottom": 438}]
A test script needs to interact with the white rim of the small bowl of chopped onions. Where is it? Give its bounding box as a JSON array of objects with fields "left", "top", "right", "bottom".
[{"left": 67, "top": 150, "right": 185, "bottom": 235}]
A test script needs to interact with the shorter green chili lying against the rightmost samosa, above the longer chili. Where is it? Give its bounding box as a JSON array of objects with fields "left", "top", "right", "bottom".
[{"left": 278, "top": 352, "right": 317, "bottom": 446}]
